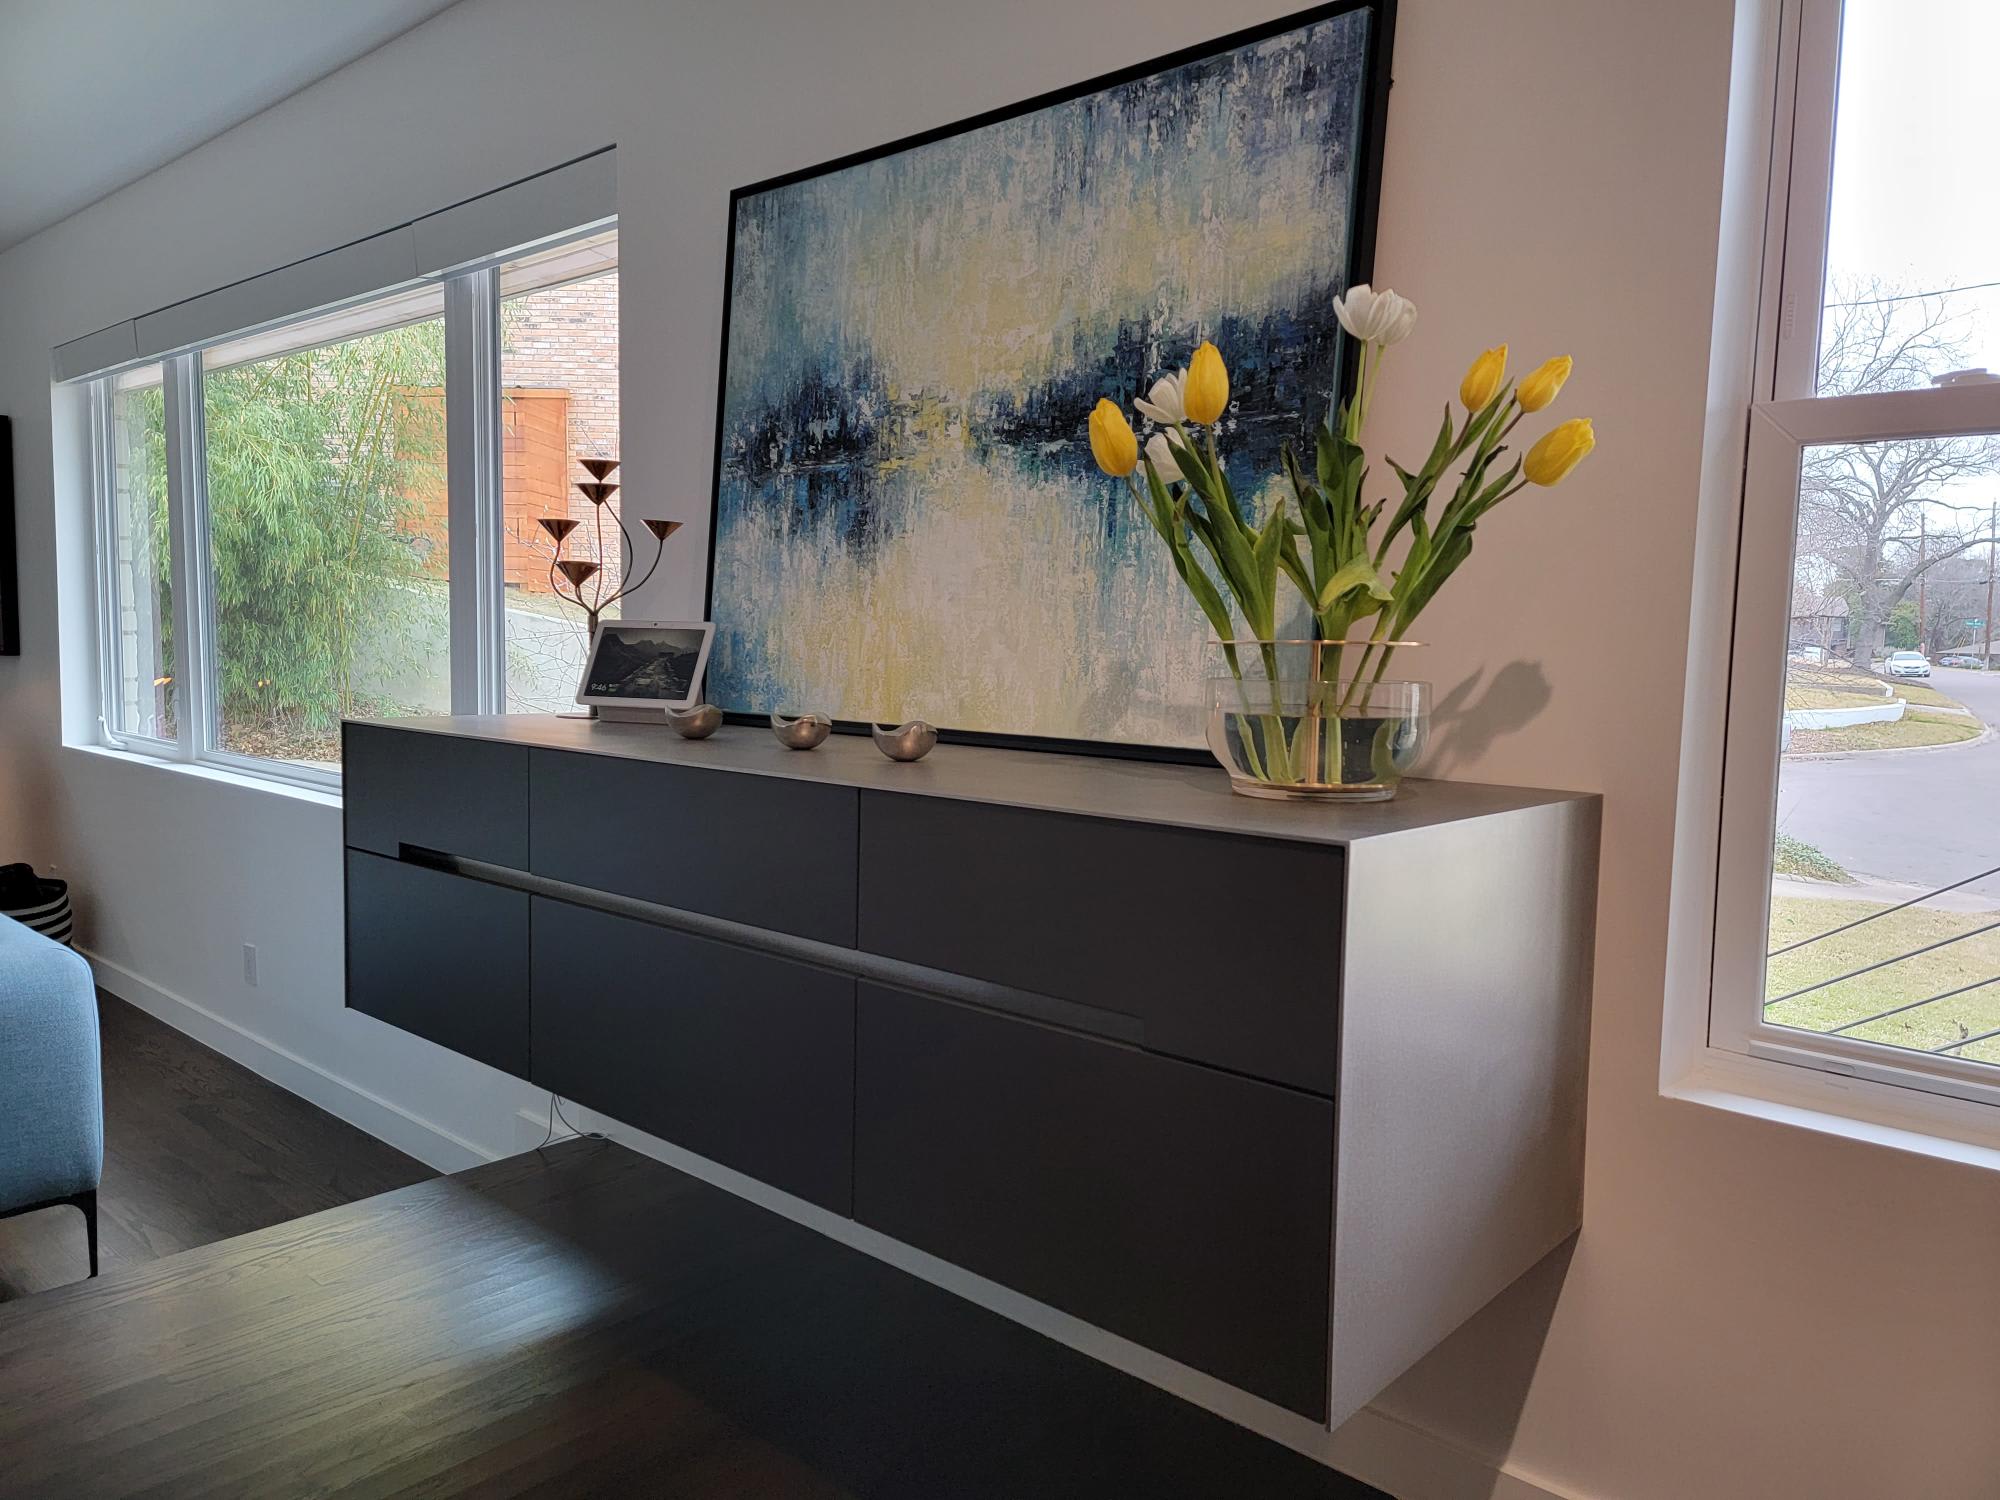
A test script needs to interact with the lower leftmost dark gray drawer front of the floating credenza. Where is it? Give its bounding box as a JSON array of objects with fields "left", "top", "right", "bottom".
[{"left": 348, "top": 850, "right": 528, "bottom": 1078}]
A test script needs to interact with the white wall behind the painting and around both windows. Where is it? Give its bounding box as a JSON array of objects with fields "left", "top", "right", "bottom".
[{"left": 0, "top": 0, "right": 2000, "bottom": 1500}]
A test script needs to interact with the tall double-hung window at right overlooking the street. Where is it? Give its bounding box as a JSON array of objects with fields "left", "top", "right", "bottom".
[{"left": 1710, "top": 0, "right": 2000, "bottom": 1102}]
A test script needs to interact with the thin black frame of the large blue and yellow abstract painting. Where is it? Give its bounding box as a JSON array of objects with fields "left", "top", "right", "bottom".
[{"left": 702, "top": 0, "right": 1398, "bottom": 766}]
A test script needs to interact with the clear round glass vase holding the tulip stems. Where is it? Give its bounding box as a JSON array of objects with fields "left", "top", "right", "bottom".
[{"left": 1208, "top": 640, "right": 1430, "bottom": 802}]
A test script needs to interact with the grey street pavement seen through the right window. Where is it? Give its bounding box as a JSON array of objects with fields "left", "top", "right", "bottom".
[{"left": 1778, "top": 668, "right": 2000, "bottom": 896}]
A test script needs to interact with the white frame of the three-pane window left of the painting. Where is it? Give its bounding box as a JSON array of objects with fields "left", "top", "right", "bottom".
[{"left": 88, "top": 222, "right": 616, "bottom": 792}]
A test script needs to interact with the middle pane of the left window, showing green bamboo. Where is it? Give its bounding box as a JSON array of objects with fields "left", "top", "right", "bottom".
[{"left": 202, "top": 288, "right": 452, "bottom": 768}]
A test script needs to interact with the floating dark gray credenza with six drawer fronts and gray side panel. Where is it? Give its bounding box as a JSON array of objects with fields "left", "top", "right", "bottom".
[{"left": 346, "top": 716, "right": 1598, "bottom": 1424}]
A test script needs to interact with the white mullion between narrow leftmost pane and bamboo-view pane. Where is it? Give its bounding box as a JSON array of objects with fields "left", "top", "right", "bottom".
[{"left": 162, "top": 354, "right": 216, "bottom": 760}]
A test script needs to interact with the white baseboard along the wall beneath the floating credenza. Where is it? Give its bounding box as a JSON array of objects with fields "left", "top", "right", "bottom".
[{"left": 80, "top": 948, "right": 1588, "bottom": 1500}]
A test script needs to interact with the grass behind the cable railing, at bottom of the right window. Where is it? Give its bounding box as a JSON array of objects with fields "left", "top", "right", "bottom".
[{"left": 1764, "top": 896, "right": 2000, "bottom": 1062}]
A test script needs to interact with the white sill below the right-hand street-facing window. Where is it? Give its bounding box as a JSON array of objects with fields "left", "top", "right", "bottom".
[{"left": 1660, "top": 1048, "right": 2000, "bottom": 1172}]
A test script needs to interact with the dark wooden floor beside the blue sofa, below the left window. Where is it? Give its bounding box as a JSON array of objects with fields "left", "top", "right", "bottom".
[{"left": 0, "top": 994, "right": 436, "bottom": 1302}]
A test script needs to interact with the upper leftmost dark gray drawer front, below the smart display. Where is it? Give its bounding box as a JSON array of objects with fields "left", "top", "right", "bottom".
[{"left": 340, "top": 724, "right": 528, "bottom": 870}]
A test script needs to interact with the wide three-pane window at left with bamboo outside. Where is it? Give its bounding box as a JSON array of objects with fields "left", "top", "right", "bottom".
[{"left": 92, "top": 232, "right": 624, "bottom": 786}]
